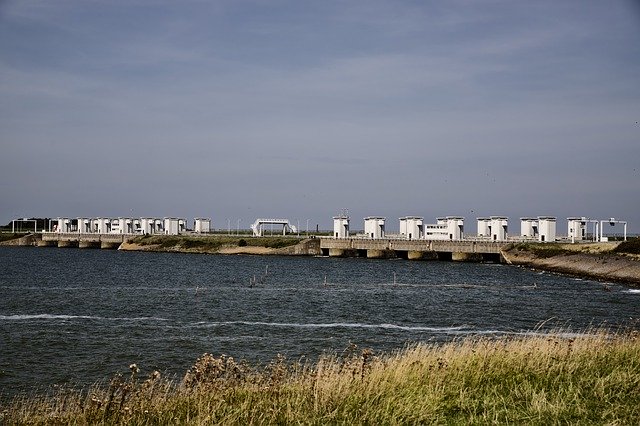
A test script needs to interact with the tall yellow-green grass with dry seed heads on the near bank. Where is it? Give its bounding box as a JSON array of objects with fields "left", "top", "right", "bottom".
[{"left": 0, "top": 333, "right": 640, "bottom": 424}]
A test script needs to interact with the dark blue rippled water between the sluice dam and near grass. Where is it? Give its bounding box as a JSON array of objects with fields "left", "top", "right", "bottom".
[{"left": 0, "top": 247, "right": 640, "bottom": 397}]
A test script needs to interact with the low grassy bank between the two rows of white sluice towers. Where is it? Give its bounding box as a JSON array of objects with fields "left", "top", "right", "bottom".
[{"left": 130, "top": 235, "right": 300, "bottom": 251}]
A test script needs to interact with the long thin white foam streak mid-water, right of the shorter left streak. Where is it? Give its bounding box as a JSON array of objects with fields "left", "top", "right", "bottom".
[{"left": 188, "top": 321, "right": 470, "bottom": 333}]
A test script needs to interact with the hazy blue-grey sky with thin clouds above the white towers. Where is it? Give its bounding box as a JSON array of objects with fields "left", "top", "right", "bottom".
[{"left": 0, "top": 0, "right": 640, "bottom": 233}]
